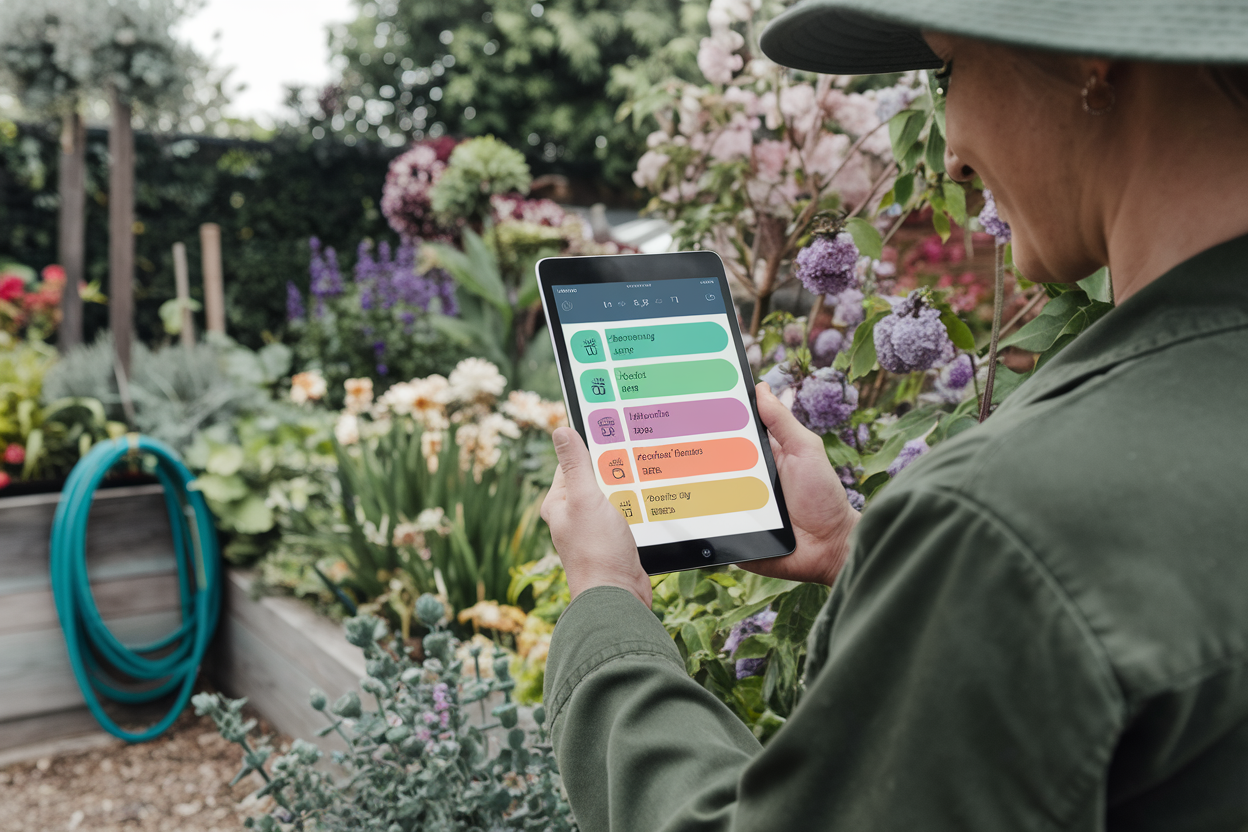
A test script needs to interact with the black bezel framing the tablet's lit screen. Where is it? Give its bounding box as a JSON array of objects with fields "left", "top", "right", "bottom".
[{"left": 537, "top": 251, "right": 796, "bottom": 575}]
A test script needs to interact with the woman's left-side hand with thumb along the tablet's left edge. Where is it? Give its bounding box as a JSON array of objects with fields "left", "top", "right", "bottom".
[{"left": 542, "top": 428, "right": 653, "bottom": 606}]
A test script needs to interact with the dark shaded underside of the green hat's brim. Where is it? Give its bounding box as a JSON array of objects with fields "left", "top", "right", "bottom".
[{"left": 759, "top": 0, "right": 942, "bottom": 75}]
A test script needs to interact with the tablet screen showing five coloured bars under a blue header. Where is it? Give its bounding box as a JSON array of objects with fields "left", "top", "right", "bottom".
[{"left": 554, "top": 277, "right": 784, "bottom": 546}]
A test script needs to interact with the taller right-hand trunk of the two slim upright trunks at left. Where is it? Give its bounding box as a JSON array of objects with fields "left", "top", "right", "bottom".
[{"left": 109, "top": 90, "right": 135, "bottom": 378}]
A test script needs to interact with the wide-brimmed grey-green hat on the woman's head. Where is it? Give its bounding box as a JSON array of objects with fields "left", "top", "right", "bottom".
[{"left": 760, "top": 0, "right": 1248, "bottom": 75}]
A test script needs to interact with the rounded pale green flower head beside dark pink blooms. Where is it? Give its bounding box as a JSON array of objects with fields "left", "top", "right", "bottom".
[{"left": 429, "top": 136, "right": 533, "bottom": 226}]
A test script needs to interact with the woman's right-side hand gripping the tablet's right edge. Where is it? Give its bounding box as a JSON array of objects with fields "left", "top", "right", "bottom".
[{"left": 738, "top": 383, "right": 860, "bottom": 586}]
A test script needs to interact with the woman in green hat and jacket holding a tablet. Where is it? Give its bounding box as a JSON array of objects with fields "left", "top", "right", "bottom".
[{"left": 543, "top": 0, "right": 1248, "bottom": 832}]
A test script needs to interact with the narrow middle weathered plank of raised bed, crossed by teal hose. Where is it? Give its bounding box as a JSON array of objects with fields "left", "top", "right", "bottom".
[{"left": 0, "top": 575, "right": 180, "bottom": 638}]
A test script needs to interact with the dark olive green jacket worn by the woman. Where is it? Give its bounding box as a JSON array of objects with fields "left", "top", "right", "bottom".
[{"left": 545, "top": 230, "right": 1248, "bottom": 832}]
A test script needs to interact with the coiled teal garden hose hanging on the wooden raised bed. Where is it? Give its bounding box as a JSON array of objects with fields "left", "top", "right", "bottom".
[{"left": 51, "top": 434, "right": 221, "bottom": 742}]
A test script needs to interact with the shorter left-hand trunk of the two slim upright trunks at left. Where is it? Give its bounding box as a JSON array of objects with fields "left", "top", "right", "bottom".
[{"left": 56, "top": 109, "right": 86, "bottom": 353}]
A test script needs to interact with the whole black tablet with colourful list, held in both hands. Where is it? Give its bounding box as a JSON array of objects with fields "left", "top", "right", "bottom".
[{"left": 537, "top": 251, "right": 794, "bottom": 575}]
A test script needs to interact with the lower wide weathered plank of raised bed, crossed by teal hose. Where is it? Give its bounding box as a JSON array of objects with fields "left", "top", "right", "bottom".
[{"left": 0, "top": 611, "right": 181, "bottom": 721}]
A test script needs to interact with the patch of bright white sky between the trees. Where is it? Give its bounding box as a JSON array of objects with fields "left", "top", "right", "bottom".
[{"left": 180, "top": 0, "right": 354, "bottom": 126}]
